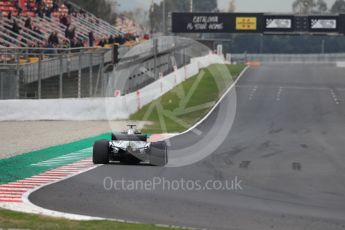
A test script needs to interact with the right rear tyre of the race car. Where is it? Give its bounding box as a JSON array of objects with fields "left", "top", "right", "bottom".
[{"left": 150, "top": 141, "right": 168, "bottom": 166}]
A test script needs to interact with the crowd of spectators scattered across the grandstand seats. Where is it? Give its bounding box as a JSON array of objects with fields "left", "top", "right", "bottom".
[{"left": 0, "top": 0, "right": 138, "bottom": 48}]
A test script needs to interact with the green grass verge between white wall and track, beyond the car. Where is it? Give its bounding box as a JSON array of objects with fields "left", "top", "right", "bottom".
[{"left": 130, "top": 64, "right": 245, "bottom": 133}]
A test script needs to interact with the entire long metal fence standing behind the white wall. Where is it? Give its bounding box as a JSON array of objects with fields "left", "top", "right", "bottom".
[{"left": 0, "top": 37, "right": 203, "bottom": 100}]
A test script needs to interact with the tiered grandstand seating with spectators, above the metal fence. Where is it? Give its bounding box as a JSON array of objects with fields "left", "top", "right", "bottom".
[{"left": 0, "top": 0, "right": 123, "bottom": 48}]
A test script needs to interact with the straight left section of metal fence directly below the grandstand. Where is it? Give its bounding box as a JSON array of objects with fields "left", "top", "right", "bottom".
[{"left": 0, "top": 48, "right": 113, "bottom": 99}]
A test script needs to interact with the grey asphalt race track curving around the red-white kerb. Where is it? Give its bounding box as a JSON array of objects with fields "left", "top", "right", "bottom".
[{"left": 29, "top": 64, "right": 345, "bottom": 230}]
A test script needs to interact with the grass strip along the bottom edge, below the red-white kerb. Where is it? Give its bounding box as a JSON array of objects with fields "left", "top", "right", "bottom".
[{"left": 0, "top": 209, "right": 176, "bottom": 230}]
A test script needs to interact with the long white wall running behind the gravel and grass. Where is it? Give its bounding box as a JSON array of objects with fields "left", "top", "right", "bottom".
[{"left": 0, "top": 54, "right": 224, "bottom": 121}]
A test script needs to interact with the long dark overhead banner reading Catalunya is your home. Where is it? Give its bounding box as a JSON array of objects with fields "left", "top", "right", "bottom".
[{"left": 171, "top": 12, "right": 345, "bottom": 34}]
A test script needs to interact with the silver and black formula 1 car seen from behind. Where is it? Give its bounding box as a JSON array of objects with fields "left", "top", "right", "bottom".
[{"left": 93, "top": 125, "right": 168, "bottom": 166}]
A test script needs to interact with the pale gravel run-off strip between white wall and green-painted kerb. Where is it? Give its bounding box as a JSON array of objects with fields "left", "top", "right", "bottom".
[{"left": 0, "top": 121, "right": 143, "bottom": 159}]
